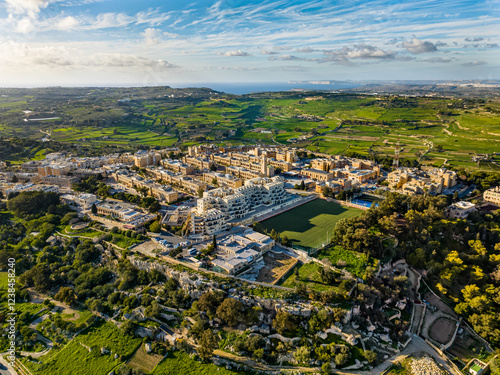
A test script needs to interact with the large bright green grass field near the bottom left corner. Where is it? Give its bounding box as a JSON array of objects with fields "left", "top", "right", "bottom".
[{"left": 25, "top": 321, "right": 141, "bottom": 375}]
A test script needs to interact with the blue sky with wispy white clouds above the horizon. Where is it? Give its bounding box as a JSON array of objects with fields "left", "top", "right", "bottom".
[{"left": 0, "top": 0, "right": 500, "bottom": 87}]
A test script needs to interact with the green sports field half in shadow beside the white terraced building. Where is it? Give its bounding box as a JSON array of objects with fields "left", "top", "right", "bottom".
[{"left": 260, "top": 199, "right": 362, "bottom": 247}]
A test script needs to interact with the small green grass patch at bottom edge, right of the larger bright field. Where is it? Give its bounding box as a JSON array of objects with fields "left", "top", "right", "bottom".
[{"left": 152, "top": 351, "right": 241, "bottom": 375}]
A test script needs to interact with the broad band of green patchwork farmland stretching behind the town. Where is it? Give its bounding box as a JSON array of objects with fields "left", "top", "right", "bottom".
[{"left": 0, "top": 87, "right": 500, "bottom": 170}]
